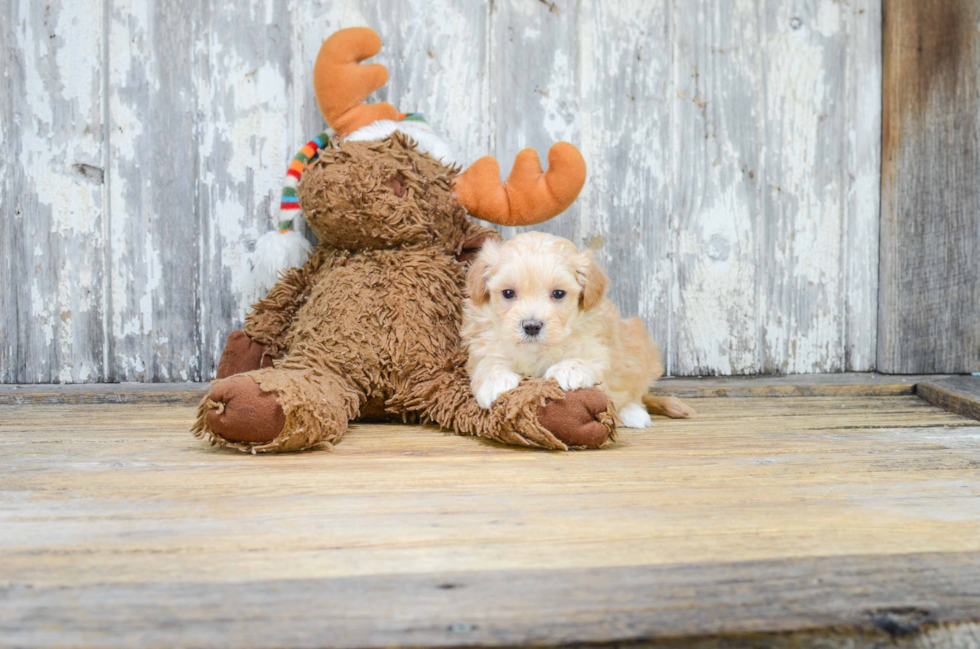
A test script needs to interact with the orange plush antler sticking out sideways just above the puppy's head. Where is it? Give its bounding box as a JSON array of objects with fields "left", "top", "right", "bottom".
[{"left": 454, "top": 142, "right": 585, "bottom": 225}]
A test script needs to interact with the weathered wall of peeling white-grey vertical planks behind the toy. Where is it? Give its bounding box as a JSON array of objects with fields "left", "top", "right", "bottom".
[{"left": 0, "top": 0, "right": 881, "bottom": 382}]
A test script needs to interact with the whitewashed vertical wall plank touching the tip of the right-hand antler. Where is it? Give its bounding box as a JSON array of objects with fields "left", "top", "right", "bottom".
[{"left": 580, "top": 0, "right": 673, "bottom": 359}]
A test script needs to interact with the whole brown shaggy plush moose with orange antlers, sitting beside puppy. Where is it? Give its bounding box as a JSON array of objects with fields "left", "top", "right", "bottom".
[{"left": 192, "top": 28, "right": 615, "bottom": 452}]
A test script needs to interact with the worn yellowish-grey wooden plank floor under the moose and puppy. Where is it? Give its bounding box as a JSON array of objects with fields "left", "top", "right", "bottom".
[{"left": 0, "top": 382, "right": 980, "bottom": 647}]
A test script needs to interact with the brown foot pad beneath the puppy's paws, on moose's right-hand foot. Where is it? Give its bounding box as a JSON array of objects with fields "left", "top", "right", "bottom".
[{"left": 538, "top": 388, "right": 614, "bottom": 448}]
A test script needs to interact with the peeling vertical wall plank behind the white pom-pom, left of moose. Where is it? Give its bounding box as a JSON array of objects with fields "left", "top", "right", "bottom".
[{"left": 194, "top": 0, "right": 294, "bottom": 370}]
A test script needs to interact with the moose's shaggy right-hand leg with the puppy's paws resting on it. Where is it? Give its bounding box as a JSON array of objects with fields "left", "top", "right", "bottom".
[{"left": 393, "top": 366, "right": 616, "bottom": 450}]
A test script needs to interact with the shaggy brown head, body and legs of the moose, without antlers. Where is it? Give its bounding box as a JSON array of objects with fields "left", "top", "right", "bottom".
[{"left": 194, "top": 133, "right": 615, "bottom": 452}]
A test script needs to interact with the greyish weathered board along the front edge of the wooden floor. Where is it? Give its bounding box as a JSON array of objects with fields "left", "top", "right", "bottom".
[{"left": 0, "top": 553, "right": 980, "bottom": 649}]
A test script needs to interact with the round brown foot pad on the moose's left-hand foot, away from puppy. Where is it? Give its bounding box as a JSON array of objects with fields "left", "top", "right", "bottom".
[{"left": 207, "top": 376, "right": 286, "bottom": 444}]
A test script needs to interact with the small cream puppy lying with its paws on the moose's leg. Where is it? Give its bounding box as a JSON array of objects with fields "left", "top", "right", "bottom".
[{"left": 462, "top": 232, "right": 694, "bottom": 428}]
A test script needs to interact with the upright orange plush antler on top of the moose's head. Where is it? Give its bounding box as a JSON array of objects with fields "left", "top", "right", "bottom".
[{"left": 313, "top": 27, "right": 398, "bottom": 137}]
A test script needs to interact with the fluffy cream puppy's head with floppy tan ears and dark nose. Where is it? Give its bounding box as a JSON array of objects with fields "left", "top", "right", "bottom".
[{"left": 469, "top": 232, "right": 607, "bottom": 345}]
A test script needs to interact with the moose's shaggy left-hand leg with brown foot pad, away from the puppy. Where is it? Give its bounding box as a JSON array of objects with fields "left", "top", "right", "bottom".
[{"left": 192, "top": 369, "right": 365, "bottom": 453}]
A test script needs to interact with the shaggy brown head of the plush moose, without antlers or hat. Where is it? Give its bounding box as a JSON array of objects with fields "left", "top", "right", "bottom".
[{"left": 299, "top": 132, "right": 466, "bottom": 254}]
